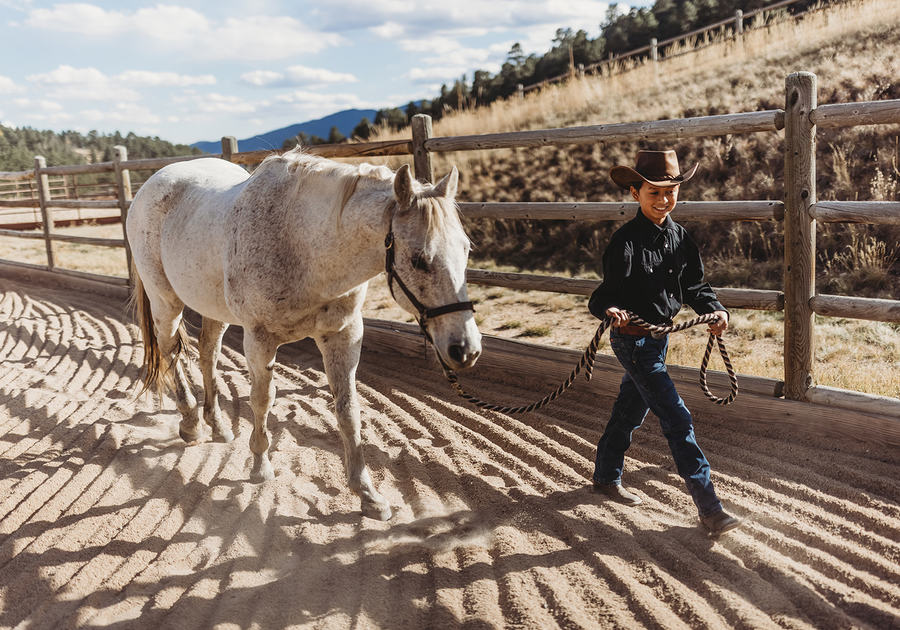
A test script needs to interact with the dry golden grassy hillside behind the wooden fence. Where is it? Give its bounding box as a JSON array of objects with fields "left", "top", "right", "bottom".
[{"left": 368, "top": 0, "right": 900, "bottom": 297}]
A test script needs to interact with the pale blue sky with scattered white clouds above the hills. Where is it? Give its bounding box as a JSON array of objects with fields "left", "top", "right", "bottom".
[{"left": 0, "top": 0, "right": 648, "bottom": 144}]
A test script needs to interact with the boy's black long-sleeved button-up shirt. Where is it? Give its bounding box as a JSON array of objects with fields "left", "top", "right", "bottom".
[{"left": 588, "top": 209, "right": 725, "bottom": 325}]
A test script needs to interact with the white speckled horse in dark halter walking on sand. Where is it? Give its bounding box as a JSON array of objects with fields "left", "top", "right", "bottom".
[{"left": 126, "top": 147, "right": 481, "bottom": 520}]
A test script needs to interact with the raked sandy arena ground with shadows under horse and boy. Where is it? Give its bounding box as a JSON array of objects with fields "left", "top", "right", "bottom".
[{"left": 0, "top": 279, "right": 900, "bottom": 630}]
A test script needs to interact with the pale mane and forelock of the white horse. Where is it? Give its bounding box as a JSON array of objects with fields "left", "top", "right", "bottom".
[{"left": 268, "top": 144, "right": 462, "bottom": 242}]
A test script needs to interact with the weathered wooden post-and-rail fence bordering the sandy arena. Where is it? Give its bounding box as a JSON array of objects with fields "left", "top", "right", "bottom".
[{"left": 0, "top": 72, "right": 900, "bottom": 436}]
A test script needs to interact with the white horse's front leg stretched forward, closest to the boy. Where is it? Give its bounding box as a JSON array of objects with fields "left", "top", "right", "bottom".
[{"left": 316, "top": 317, "right": 391, "bottom": 521}]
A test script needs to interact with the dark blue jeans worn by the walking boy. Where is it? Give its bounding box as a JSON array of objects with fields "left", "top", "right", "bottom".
[{"left": 594, "top": 328, "right": 722, "bottom": 516}]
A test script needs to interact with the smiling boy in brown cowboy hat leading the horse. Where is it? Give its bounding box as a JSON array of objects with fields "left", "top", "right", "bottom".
[{"left": 588, "top": 151, "right": 740, "bottom": 535}]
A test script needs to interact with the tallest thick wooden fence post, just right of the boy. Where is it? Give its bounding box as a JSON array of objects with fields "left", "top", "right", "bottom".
[{"left": 784, "top": 72, "right": 817, "bottom": 400}]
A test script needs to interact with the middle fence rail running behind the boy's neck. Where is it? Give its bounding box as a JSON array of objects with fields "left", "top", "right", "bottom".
[{"left": 459, "top": 201, "right": 784, "bottom": 221}]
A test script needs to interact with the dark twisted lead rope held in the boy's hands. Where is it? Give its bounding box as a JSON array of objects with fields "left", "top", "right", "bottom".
[{"left": 441, "top": 312, "right": 738, "bottom": 414}]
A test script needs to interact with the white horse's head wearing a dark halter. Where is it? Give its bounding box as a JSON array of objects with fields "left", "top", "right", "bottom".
[{"left": 385, "top": 165, "right": 481, "bottom": 369}]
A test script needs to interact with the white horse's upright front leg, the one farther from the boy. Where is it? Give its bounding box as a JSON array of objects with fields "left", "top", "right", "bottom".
[{"left": 244, "top": 329, "right": 278, "bottom": 483}]
